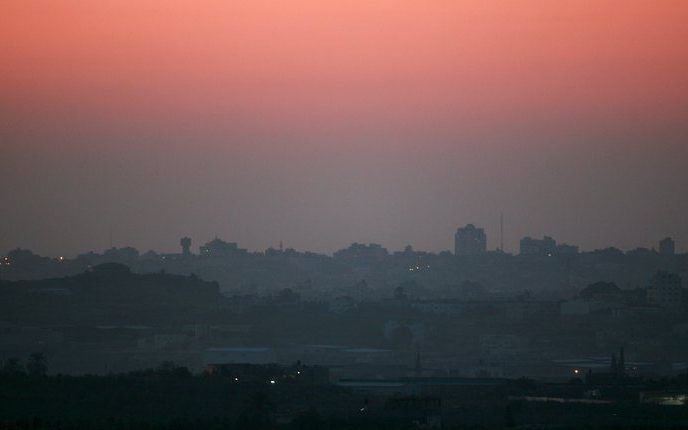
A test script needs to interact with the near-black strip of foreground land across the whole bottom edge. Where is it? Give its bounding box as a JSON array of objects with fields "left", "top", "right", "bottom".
[{"left": 0, "top": 363, "right": 688, "bottom": 430}]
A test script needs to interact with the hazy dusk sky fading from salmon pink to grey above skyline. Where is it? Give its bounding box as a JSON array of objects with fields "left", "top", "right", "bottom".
[{"left": 0, "top": 0, "right": 688, "bottom": 256}]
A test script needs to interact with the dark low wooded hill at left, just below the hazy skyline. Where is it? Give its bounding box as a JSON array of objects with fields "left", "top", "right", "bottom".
[{"left": 0, "top": 263, "right": 222, "bottom": 325}]
